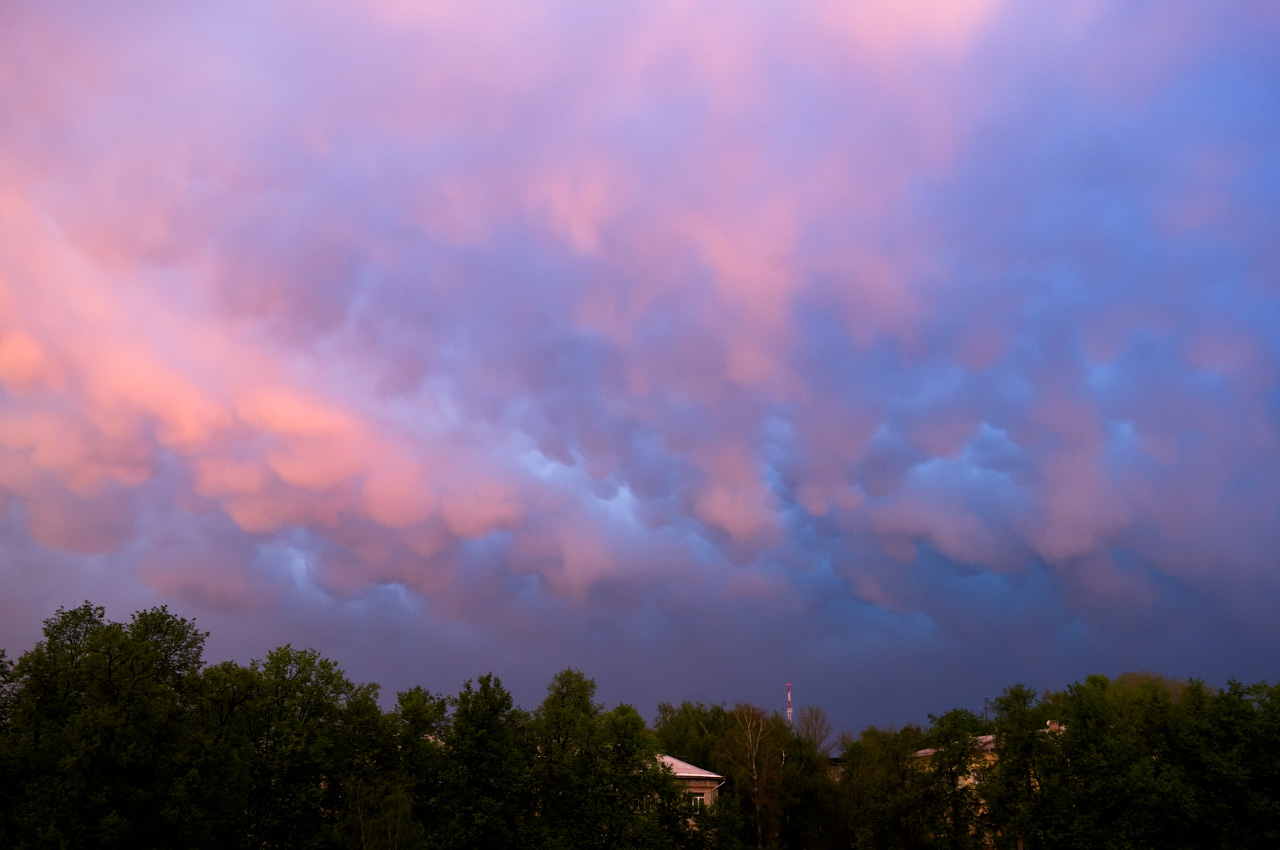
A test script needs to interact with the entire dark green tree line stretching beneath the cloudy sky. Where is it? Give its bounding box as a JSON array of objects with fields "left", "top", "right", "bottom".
[{"left": 0, "top": 603, "right": 1280, "bottom": 850}]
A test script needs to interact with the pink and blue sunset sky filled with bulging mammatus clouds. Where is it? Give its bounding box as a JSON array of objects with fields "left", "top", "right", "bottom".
[{"left": 0, "top": 0, "right": 1280, "bottom": 731}]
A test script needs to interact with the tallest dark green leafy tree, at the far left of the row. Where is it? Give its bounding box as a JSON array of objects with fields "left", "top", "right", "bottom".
[{"left": 6, "top": 603, "right": 205, "bottom": 847}]
